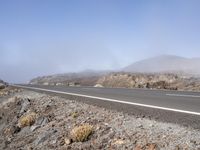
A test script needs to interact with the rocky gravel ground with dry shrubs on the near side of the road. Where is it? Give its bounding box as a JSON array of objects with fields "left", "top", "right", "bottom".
[{"left": 0, "top": 84, "right": 200, "bottom": 150}]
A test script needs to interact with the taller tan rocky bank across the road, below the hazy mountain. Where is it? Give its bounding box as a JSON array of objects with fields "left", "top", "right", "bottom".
[{"left": 97, "top": 73, "right": 200, "bottom": 91}]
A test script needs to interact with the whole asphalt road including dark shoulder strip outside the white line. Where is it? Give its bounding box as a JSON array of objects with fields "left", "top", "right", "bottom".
[{"left": 12, "top": 85, "right": 200, "bottom": 129}]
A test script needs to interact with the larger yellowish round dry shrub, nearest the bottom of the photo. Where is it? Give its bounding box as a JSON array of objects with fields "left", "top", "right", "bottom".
[{"left": 71, "top": 124, "right": 93, "bottom": 142}]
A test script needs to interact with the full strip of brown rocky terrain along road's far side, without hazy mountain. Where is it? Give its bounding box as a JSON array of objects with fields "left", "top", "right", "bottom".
[{"left": 30, "top": 72, "right": 200, "bottom": 91}]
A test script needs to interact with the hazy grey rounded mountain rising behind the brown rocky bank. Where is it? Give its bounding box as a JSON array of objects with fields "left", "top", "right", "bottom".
[{"left": 122, "top": 55, "right": 200, "bottom": 75}]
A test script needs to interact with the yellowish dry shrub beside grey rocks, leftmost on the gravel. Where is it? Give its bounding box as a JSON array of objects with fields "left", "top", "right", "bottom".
[{"left": 19, "top": 112, "right": 36, "bottom": 127}]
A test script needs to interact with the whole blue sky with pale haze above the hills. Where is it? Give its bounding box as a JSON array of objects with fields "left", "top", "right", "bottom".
[{"left": 0, "top": 0, "right": 200, "bottom": 83}]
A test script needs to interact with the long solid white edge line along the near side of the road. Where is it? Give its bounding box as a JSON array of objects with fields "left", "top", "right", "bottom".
[{"left": 13, "top": 85, "right": 200, "bottom": 116}]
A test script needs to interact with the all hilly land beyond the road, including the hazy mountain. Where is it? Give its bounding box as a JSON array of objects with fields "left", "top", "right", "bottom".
[{"left": 30, "top": 55, "right": 200, "bottom": 91}]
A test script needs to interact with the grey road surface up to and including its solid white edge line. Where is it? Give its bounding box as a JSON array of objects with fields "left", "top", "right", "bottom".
[{"left": 12, "top": 85, "right": 200, "bottom": 116}]
